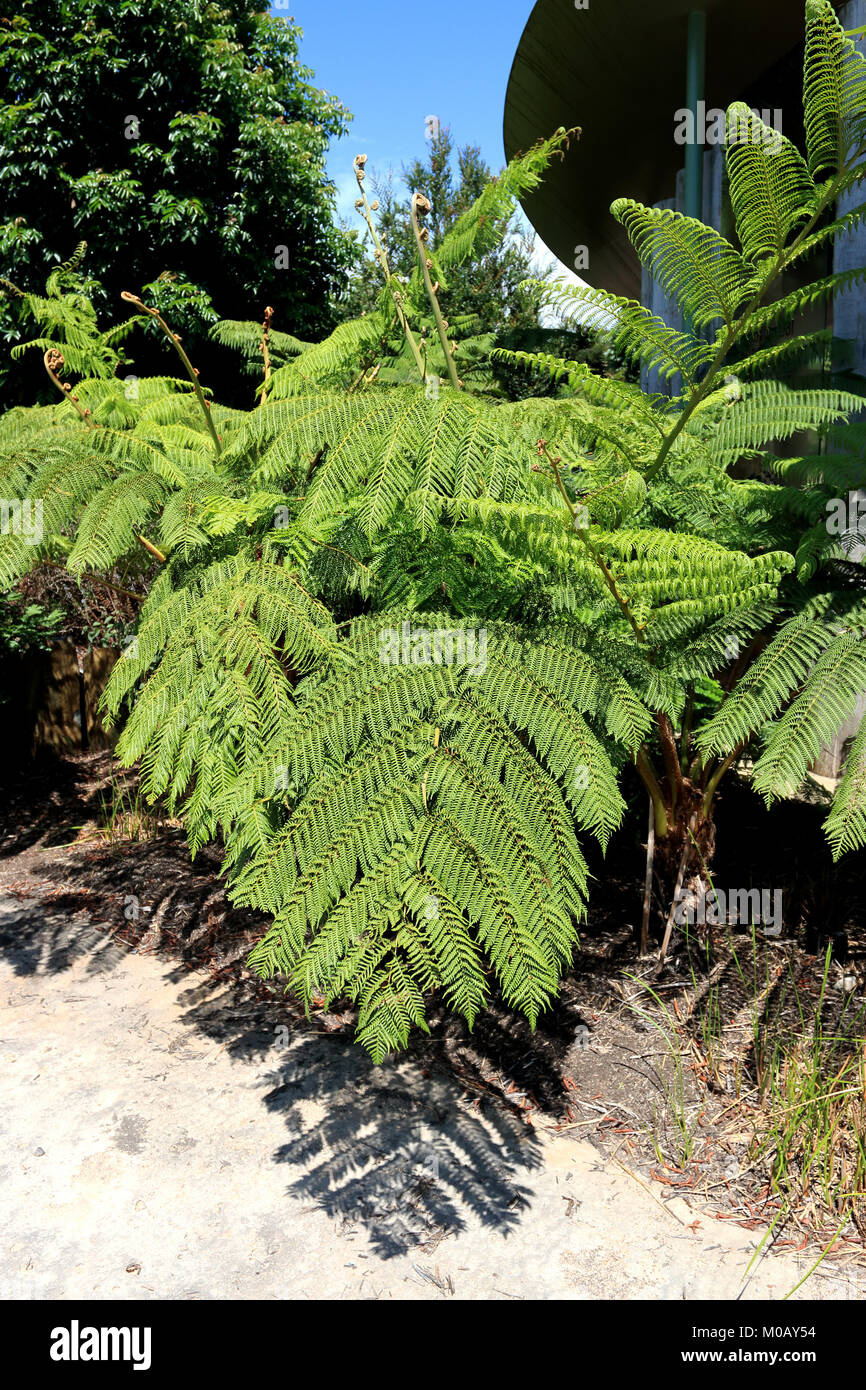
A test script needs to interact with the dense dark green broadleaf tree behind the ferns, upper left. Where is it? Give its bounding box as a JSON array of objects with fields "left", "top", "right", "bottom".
[{"left": 0, "top": 0, "right": 349, "bottom": 403}]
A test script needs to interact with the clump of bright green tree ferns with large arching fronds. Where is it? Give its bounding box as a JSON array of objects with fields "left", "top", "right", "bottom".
[{"left": 0, "top": 0, "right": 866, "bottom": 1059}]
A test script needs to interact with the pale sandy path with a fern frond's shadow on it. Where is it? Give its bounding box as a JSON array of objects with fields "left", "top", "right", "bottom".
[{"left": 0, "top": 898, "right": 863, "bottom": 1300}]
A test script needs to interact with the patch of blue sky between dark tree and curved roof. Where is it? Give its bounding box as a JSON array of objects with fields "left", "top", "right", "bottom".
[{"left": 271, "top": 0, "right": 534, "bottom": 233}]
